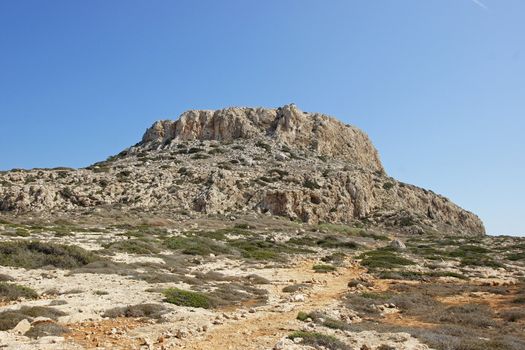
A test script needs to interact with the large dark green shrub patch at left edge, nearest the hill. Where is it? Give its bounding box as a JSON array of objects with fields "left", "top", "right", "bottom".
[{"left": 0, "top": 241, "right": 101, "bottom": 269}]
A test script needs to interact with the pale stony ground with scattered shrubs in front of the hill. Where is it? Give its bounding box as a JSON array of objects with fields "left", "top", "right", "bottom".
[{"left": 0, "top": 214, "right": 525, "bottom": 350}]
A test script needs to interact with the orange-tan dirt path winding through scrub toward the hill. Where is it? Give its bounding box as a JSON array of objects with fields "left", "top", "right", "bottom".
[{"left": 184, "top": 261, "right": 362, "bottom": 350}]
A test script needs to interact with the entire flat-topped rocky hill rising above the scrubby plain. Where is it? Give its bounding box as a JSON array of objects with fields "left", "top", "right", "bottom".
[{"left": 0, "top": 105, "right": 485, "bottom": 235}]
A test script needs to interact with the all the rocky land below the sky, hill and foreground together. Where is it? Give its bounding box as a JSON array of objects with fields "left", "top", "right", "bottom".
[{"left": 0, "top": 105, "right": 525, "bottom": 350}]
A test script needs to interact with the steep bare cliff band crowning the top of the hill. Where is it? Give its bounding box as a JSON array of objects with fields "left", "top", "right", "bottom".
[{"left": 142, "top": 104, "right": 384, "bottom": 173}]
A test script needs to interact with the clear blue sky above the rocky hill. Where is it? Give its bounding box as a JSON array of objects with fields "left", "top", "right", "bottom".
[{"left": 0, "top": 0, "right": 525, "bottom": 234}]
